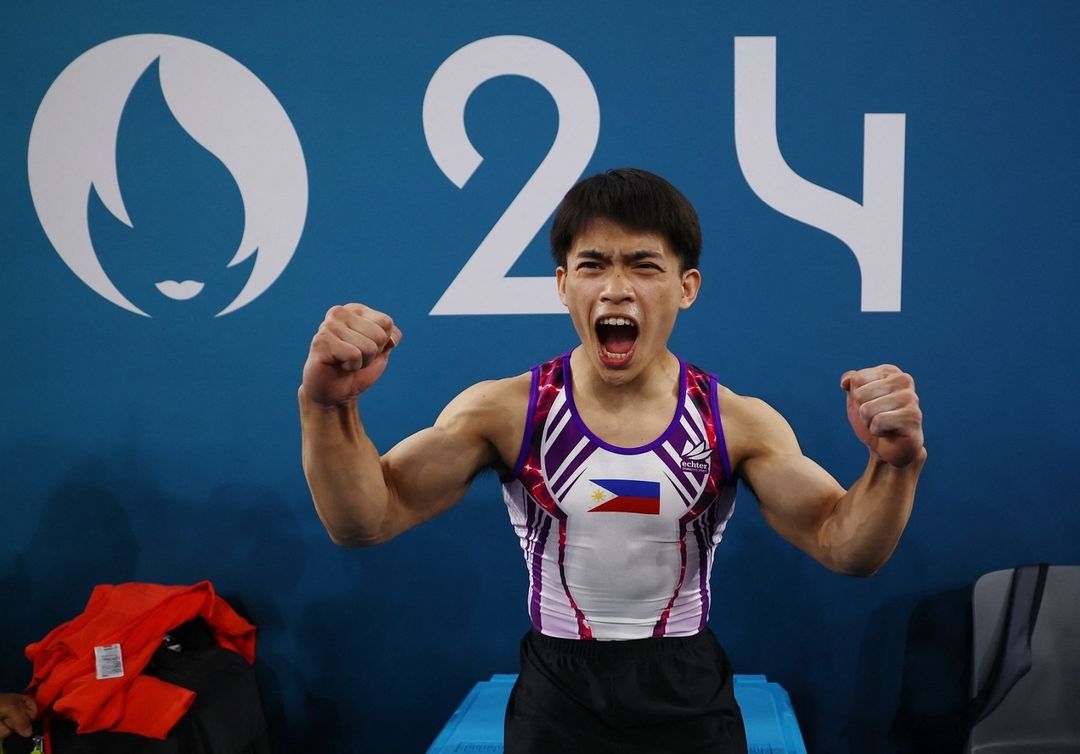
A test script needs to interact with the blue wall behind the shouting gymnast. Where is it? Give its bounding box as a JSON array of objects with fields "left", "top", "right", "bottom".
[{"left": 0, "top": 0, "right": 1080, "bottom": 754}]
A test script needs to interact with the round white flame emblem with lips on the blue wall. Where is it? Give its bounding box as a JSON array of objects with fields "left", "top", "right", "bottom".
[{"left": 27, "top": 35, "right": 308, "bottom": 317}]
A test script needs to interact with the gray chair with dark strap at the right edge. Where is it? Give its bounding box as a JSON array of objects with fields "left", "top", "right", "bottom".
[{"left": 967, "top": 566, "right": 1080, "bottom": 754}]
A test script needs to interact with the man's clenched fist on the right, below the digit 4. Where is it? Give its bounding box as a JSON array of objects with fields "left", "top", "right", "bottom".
[{"left": 840, "top": 364, "right": 923, "bottom": 467}]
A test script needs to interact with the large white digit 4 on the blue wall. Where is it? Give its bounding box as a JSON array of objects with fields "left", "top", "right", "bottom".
[{"left": 734, "top": 37, "right": 904, "bottom": 311}]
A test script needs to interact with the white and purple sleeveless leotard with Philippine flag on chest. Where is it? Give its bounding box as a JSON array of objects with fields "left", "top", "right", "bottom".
[{"left": 502, "top": 353, "right": 735, "bottom": 639}]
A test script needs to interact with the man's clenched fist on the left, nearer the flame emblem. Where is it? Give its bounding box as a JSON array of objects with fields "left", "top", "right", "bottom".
[{"left": 303, "top": 304, "right": 402, "bottom": 406}]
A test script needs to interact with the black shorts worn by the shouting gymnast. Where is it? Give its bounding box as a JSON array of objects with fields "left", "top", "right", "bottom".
[{"left": 505, "top": 629, "right": 746, "bottom": 754}]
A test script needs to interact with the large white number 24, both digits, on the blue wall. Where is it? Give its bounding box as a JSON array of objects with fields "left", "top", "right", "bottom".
[{"left": 423, "top": 36, "right": 904, "bottom": 314}]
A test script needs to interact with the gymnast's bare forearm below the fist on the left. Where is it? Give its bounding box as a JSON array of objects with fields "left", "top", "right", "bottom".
[{"left": 299, "top": 388, "right": 390, "bottom": 547}]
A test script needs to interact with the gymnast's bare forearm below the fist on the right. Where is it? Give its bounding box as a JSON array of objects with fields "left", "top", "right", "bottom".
[{"left": 819, "top": 449, "right": 927, "bottom": 576}]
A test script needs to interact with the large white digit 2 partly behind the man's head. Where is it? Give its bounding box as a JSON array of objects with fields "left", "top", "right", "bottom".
[{"left": 423, "top": 36, "right": 600, "bottom": 314}]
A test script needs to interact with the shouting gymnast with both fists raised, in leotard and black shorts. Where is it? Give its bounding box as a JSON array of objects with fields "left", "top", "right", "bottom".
[{"left": 299, "top": 170, "right": 927, "bottom": 754}]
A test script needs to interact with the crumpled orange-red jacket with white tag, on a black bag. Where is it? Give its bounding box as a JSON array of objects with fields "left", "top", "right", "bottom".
[{"left": 26, "top": 581, "right": 255, "bottom": 739}]
